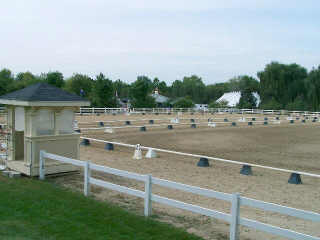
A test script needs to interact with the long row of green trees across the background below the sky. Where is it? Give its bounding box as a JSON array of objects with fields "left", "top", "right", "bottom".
[{"left": 0, "top": 62, "right": 320, "bottom": 111}]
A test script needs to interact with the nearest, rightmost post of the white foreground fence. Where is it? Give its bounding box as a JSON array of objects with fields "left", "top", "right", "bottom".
[{"left": 230, "top": 193, "right": 240, "bottom": 240}]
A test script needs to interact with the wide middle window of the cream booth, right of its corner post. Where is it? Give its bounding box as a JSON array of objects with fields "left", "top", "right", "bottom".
[{"left": 35, "top": 110, "right": 54, "bottom": 136}]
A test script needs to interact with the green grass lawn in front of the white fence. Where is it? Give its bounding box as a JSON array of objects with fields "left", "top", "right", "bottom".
[{"left": 0, "top": 176, "right": 201, "bottom": 240}]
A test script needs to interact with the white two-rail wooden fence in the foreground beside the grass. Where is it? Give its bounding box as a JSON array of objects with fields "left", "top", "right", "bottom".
[{"left": 39, "top": 151, "right": 320, "bottom": 240}]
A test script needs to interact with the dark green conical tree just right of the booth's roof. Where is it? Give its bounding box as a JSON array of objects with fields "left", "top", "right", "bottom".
[{"left": 91, "top": 73, "right": 117, "bottom": 107}]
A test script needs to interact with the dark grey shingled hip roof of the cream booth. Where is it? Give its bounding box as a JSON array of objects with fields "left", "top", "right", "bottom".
[{"left": 0, "top": 83, "right": 89, "bottom": 106}]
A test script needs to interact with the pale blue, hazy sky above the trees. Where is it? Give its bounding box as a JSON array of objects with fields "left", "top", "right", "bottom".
[{"left": 0, "top": 0, "right": 320, "bottom": 84}]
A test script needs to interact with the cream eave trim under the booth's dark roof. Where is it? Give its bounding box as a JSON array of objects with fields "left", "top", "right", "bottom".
[{"left": 0, "top": 99, "right": 90, "bottom": 107}]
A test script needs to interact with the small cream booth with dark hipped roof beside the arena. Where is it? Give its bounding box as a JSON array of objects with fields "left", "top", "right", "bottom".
[{"left": 0, "top": 83, "right": 90, "bottom": 176}]
